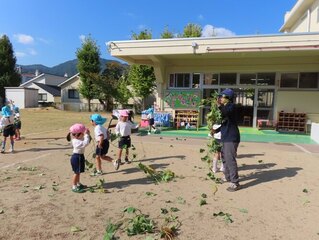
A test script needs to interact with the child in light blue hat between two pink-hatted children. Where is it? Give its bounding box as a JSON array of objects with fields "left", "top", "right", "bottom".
[{"left": 91, "top": 114, "right": 120, "bottom": 175}]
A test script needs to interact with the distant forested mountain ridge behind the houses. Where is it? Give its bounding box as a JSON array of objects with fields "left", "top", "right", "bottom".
[{"left": 18, "top": 58, "right": 127, "bottom": 77}]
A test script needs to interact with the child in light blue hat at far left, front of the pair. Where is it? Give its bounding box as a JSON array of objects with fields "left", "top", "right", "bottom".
[{"left": 0, "top": 102, "right": 15, "bottom": 153}]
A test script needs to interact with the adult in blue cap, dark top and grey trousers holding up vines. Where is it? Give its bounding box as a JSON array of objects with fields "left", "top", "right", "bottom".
[{"left": 218, "top": 89, "right": 241, "bottom": 192}]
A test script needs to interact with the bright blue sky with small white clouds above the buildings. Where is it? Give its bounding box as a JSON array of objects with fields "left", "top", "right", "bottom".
[{"left": 0, "top": 0, "right": 297, "bottom": 67}]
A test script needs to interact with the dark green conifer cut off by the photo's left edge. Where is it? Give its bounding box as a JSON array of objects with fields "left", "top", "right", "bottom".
[{"left": 0, "top": 35, "right": 21, "bottom": 104}]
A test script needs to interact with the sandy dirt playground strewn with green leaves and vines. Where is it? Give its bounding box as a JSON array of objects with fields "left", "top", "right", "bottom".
[{"left": 0, "top": 109, "right": 319, "bottom": 240}]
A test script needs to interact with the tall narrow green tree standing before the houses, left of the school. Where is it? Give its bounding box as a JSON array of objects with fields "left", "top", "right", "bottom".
[{"left": 76, "top": 37, "right": 101, "bottom": 112}]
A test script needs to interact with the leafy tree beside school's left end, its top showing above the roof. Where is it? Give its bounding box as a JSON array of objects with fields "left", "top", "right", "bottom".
[{"left": 128, "top": 29, "right": 156, "bottom": 108}]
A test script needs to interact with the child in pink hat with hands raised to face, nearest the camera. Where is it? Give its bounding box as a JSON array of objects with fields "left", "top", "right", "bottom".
[{"left": 67, "top": 123, "right": 91, "bottom": 193}]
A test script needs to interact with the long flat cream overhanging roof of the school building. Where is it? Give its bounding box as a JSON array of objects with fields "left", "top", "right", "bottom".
[{"left": 107, "top": 33, "right": 319, "bottom": 66}]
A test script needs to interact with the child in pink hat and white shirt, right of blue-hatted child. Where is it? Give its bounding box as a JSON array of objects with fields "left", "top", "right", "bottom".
[{"left": 115, "top": 110, "right": 138, "bottom": 163}]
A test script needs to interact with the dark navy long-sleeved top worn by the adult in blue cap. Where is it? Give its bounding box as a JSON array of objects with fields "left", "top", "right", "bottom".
[{"left": 219, "top": 103, "right": 240, "bottom": 143}]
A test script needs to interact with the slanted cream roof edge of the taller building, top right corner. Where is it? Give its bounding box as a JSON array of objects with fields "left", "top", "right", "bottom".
[{"left": 279, "top": 0, "right": 315, "bottom": 32}]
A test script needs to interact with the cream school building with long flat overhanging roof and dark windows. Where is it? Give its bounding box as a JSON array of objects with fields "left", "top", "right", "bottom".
[{"left": 107, "top": 0, "right": 319, "bottom": 127}]
